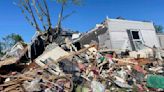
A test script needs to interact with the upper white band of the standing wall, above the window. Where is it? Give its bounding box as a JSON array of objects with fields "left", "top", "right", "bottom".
[{"left": 106, "top": 18, "right": 155, "bottom": 31}]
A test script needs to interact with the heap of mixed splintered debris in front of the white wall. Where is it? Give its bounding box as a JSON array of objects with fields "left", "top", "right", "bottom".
[{"left": 0, "top": 32, "right": 164, "bottom": 92}]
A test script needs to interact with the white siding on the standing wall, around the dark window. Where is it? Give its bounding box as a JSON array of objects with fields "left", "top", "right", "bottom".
[{"left": 107, "top": 19, "right": 159, "bottom": 49}]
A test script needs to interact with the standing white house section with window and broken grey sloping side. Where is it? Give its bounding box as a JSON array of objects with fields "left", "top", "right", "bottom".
[{"left": 80, "top": 18, "right": 160, "bottom": 50}]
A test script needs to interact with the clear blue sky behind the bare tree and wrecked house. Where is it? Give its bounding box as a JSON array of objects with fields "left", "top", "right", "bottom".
[{"left": 0, "top": 0, "right": 164, "bottom": 42}]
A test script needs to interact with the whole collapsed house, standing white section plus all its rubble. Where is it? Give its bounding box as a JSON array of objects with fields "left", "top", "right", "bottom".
[{"left": 0, "top": 18, "right": 164, "bottom": 92}]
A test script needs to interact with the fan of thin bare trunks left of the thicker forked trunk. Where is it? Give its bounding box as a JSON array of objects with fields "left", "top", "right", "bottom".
[{"left": 17, "top": 0, "right": 52, "bottom": 32}]
